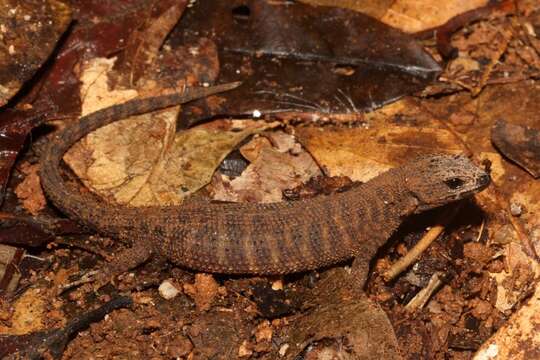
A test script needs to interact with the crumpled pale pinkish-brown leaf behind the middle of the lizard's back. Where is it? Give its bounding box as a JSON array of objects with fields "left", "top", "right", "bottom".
[{"left": 212, "top": 133, "right": 321, "bottom": 202}]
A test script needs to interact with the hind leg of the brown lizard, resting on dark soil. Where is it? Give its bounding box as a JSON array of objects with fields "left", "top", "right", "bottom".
[{"left": 94, "top": 239, "right": 153, "bottom": 290}]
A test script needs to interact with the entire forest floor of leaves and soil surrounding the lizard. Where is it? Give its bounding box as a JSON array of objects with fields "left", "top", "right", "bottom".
[{"left": 0, "top": 0, "right": 540, "bottom": 360}]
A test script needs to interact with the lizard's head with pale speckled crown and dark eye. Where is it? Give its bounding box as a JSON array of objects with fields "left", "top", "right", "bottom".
[{"left": 404, "top": 155, "right": 491, "bottom": 212}]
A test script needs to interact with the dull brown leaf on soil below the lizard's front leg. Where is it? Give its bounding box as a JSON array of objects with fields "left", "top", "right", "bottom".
[{"left": 286, "top": 269, "right": 401, "bottom": 360}]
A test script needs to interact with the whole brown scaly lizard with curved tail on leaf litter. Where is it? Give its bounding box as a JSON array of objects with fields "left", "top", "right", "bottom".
[{"left": 40, "top": 83, "right": 490, "bottom": 284}]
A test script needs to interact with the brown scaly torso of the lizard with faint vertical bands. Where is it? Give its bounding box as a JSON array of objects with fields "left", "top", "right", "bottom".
[{"left": 146, "top": 174, "right": 416, "bottom": 274}]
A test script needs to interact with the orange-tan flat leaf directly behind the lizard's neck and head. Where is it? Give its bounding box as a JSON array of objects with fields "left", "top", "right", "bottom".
[{"left": 297, "top": 100, "right": 463, "bottom": 182}]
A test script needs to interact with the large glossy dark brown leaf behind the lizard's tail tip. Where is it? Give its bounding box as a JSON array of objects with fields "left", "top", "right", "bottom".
[{"left": 179, "top": 0, "right": 440, "bottom": 125}]
